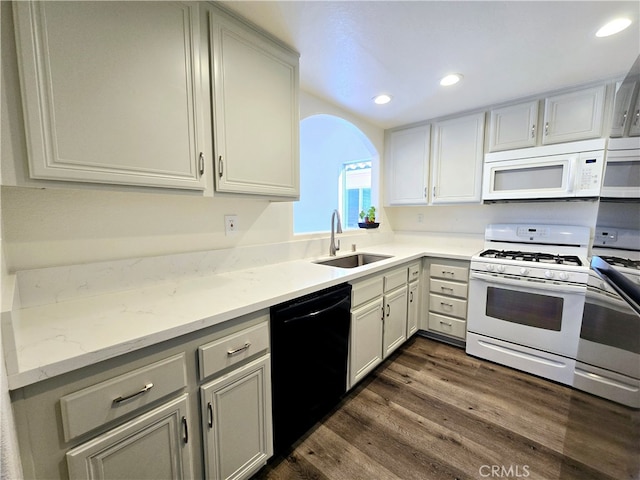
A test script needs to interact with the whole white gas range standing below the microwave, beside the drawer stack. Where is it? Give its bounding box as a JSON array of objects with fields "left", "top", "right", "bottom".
[{"left": 466, "top": 224, "right": 590, "bottom": 385}]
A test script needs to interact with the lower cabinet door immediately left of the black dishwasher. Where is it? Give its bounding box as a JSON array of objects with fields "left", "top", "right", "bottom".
[{"left": 200, "top": 355, "right": 273, "bottom": 480}]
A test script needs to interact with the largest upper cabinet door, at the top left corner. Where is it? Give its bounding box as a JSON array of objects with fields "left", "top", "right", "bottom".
[{"left": 14, "top": 2, "right": 205, "bottom": 190}]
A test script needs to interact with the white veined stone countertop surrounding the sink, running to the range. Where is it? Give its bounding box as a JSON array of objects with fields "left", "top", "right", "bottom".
[{"left": 3, "top": 239, "right": 479, "bottom": 390}]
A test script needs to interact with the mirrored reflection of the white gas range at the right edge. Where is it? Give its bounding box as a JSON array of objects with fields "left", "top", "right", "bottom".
[{"left": 573, "top": 226, "right": 640, "bottom": 408}]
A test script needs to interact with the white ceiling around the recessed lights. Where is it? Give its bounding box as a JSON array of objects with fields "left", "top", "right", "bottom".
[{"left": 222, "top": 0, "right": 640, "bottom": 128}]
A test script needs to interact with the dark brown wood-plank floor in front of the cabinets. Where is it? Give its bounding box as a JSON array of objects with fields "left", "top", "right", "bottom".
[{"left": 254, "top": 337, "right": 640, "bottom": 480}]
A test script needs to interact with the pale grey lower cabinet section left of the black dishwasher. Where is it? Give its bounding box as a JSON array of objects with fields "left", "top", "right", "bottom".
[{"left": 11, "top": 310, "right": 273, "bottom": 480}]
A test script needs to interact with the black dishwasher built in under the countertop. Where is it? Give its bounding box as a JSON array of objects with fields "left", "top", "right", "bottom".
[{"left": 271, "top": 284, "right": 351, "bottom": 453}]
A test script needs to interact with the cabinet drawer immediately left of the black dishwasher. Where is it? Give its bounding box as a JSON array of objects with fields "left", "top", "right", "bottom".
[{"left": 198, "top": 322, "right": 269, "bottom": 380}]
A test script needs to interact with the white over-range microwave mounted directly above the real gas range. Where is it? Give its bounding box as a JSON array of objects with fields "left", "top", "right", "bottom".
[{"left": 482, "top": 139, "right": 606, "bottom": 202}]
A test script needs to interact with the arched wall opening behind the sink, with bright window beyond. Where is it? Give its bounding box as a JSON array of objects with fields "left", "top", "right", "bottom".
[{"left": 293, "top": 114, "right": 379, "bottom": 234}]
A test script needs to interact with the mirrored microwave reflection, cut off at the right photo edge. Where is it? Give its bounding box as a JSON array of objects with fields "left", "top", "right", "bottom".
[{"left": 600, "top": 137, "right": 640, "bottom": 199}]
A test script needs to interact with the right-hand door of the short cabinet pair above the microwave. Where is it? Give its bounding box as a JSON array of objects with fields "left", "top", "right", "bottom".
[{"left": 542, "top": 85, "right": 605, "bottom": 145}]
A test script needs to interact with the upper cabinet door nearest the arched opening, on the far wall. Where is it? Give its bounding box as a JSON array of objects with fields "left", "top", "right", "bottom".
[{"left": 386, "top": 125, "right": 431, "bottom": 205}]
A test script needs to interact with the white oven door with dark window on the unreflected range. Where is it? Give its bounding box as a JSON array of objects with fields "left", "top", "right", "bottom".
[{"left": 467, "top": 271, "right": 586, "bottom": 359}]
